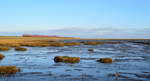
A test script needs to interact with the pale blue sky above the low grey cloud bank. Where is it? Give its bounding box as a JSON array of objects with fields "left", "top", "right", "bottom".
[{"left": 0, "top": 0, "right": 150, "bottom": 38}]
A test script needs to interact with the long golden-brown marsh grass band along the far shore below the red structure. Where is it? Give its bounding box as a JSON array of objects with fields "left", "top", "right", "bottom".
[{"left": 0, "top": 36, "right": 121, "bottom": 47}]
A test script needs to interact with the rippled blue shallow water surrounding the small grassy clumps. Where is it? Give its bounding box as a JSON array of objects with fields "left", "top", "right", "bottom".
[{"left": 0, "top": 42, "right": 150, "bottom": 81}]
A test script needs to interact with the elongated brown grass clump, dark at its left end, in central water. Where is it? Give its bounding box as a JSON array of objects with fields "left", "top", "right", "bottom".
[{"left": 54, "top": 56, "right": 80, "bottom": 63}]
